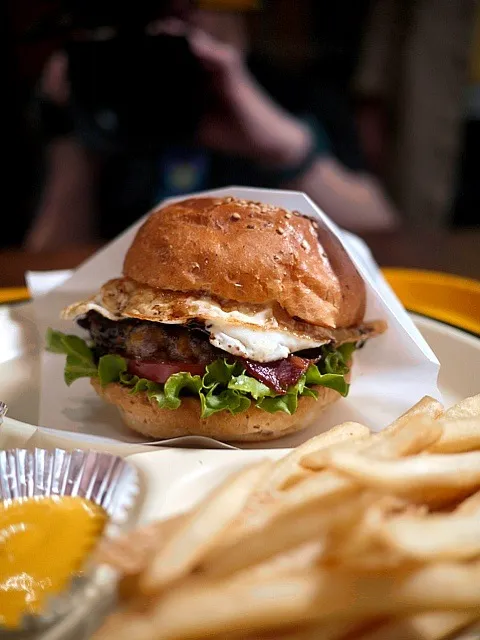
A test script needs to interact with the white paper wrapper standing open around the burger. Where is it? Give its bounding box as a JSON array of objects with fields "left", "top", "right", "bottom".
[{"left": 34, "top": 187, "right": 441, "bottom": 448}]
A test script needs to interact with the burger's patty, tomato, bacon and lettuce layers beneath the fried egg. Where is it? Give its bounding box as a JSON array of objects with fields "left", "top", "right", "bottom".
[{"left": 47, "top": 310, "right": 366, "bottom": 417}]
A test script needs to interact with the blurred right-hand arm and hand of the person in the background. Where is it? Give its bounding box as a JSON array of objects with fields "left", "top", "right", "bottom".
[{"left": 192, "top": 27, "right": 398, "bottom": 232}]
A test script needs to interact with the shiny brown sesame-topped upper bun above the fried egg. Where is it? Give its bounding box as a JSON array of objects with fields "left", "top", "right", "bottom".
[{"left": 123, "top": 198, "right": 366, "bottom": 330}]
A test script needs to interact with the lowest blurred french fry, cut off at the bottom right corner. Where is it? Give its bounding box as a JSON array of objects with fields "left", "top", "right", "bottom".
[{"left": 355, "top": 611, "right": 477, "bottom": 640}]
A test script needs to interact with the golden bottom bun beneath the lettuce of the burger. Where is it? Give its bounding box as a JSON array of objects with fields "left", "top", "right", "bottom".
[{"left": 91, "top": 378, "right": 341, "bottom": 442}]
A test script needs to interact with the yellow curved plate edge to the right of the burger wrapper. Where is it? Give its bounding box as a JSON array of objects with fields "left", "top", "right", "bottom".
[{"left": 382, "top": 268, "right": 480, "bottom": 335}]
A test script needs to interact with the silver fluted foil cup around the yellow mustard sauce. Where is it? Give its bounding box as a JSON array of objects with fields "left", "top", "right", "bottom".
[{"left": 0, "top": 448, "right": 139, "bottom": 639}]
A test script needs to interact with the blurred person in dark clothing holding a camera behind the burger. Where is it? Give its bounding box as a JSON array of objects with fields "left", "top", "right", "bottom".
[{"left": 25, "top": 0, "right": 396, "bottom": 251}]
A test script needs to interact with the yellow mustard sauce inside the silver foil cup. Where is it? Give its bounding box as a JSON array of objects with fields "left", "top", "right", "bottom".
[{"left": 0, "top": 496, "right": 107, "bottom": 628}]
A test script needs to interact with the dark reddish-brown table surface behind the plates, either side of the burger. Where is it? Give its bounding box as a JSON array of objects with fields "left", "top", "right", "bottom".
[{"left": 0, "top": 229, "right": 480, "bottom": 287}]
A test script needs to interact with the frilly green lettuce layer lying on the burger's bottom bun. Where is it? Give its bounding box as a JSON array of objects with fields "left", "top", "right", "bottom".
[{"left": 46, "top": 329, "right": 355, "bottom": 418}]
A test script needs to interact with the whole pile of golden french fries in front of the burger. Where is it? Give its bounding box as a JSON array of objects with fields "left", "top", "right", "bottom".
[{"left": 95, "top": 395, "right": 480, "bottom": 640}]
